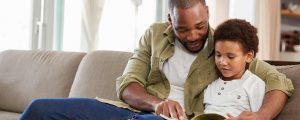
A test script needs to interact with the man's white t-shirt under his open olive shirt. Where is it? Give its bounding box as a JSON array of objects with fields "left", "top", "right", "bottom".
[{"left": 163, "top": 39, "right": 207, "bottom": 108}]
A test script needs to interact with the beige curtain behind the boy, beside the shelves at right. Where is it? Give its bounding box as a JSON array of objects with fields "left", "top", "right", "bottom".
[{"left": 256, "top": 0, "right": 281, "bottom": 60}]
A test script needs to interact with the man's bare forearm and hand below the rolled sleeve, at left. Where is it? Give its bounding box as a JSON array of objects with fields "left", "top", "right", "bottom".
[{"left": 121, "top": 82, "right": 187, "bottom": 120}]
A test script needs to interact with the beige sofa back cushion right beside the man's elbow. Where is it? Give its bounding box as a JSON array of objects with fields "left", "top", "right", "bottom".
[{"left": 69, "top": 51, "right": 133, "bottom": 100}]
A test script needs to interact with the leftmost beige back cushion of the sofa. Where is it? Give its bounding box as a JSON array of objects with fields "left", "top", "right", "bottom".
[{"left": 0, "top": 50, "right": 85, "bottom": 112}]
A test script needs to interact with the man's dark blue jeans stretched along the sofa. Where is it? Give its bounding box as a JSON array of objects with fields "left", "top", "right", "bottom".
[{"left": 20, "top": 98, "right": 163, "bottom": 120}]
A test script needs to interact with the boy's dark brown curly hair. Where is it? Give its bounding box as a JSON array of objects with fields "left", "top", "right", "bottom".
[{"left": 214, "top": 19, "right": 258, "bottom": 56}]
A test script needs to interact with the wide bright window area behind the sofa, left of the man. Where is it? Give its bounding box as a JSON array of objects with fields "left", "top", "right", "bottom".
[{"left": 0, "top": 0, "right": 165, "bottom": 52}]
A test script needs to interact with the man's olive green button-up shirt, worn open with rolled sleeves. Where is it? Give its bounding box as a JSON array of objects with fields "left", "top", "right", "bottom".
[{"left": 108, "top": 23, "right": 294, "bottom": 116}]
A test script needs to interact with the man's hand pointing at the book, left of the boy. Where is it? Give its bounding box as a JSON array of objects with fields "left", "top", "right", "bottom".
[{"left": 155, "top": 100, "right": 187, "bottom": 120}]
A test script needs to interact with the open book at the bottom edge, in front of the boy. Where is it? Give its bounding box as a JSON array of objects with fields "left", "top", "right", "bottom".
[{"left": 160, "top": 113, "right": 226, "bottom": 120}]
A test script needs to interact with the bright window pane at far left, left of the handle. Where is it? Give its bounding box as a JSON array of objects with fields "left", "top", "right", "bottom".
[{"left": 0, "top": 0, "right": 32, "bottom": 51}]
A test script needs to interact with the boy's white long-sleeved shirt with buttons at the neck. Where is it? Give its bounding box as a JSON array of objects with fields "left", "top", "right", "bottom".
[{"left": 204, "top": 70, "right": 265, "bottom": 117}]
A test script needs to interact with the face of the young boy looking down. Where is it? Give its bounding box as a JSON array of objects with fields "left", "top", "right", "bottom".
[{"left": 215, "top": 40, "right": 254, "bottom": 80}]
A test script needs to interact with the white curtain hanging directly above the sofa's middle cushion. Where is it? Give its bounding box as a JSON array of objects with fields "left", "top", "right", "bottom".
[{"left": 81, "top": 0, "right": 105, "bottom": 52}]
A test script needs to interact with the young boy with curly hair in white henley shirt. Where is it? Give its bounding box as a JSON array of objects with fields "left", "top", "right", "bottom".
[{"left": 204, "top": 19, "right": 265, "bottom": 118}]
